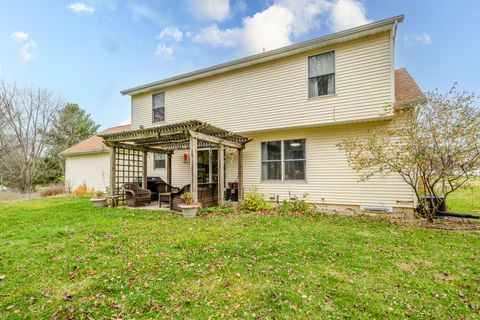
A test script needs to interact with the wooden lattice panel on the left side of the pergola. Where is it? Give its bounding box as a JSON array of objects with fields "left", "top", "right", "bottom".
[{"left": 115, "top": 147, "right": 144, "bottom": 204}]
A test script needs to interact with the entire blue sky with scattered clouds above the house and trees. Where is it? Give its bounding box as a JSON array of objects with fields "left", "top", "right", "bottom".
[{"left": 0, "top": 0, "right": 480, "bottom": 128}]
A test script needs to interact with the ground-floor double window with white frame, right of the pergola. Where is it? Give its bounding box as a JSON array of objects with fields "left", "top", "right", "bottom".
[{"left": 262, "top": 139, "right": 306, "bottom": 181}]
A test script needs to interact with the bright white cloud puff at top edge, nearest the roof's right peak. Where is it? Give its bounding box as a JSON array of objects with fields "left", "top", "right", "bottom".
[{"left": 330, "top": 0, "right": 370, "bottom": 31}]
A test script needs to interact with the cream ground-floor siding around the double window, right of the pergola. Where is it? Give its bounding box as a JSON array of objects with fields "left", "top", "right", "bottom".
[{"left": 244, "top": 121, "right": 413, "bottom": 208}]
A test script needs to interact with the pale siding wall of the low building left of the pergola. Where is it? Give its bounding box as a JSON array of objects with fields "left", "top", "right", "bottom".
[{"left": 65, "top": 152, "right": 110, "bottom": 191}]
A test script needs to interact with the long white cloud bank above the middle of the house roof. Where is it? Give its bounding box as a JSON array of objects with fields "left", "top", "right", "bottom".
[{"left": 193, "top": 0, "right": 369, "bottom": 54}]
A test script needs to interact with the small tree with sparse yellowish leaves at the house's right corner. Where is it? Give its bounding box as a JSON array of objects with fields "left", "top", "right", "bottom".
[{"left": 339, "top": 86, "right": 480, "bottom": 222}]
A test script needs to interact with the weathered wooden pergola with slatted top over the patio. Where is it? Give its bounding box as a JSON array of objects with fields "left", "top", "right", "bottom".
[{"left": 99, "top": 120, "right": 250, "bottom": 204}]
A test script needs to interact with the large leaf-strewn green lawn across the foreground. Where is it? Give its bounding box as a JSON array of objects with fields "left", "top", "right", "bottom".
[{"left": 0, "top": 198, "right": 480, "bottom": 319}]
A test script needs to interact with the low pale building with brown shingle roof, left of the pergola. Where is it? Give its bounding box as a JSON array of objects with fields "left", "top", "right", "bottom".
[{"left": 60, "top": 125, "right": 130, "bottom": 191}]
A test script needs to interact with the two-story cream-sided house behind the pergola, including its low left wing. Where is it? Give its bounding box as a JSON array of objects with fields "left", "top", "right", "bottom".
[{"left": 63, "top": 16, "right": 422, "bottom": 215}]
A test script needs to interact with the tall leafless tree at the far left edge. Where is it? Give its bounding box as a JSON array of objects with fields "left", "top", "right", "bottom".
[{"left": 0, "top": 81, "right": 62, "bottom": 192}]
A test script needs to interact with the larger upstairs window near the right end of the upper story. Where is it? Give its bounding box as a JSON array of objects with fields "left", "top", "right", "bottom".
[{"left": 308, "top": 51, "right": 335, "bottom": 98}]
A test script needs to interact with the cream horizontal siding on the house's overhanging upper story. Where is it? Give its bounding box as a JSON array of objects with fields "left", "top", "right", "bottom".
[{"left": 132, "top": 32, "right": 393, "bottom": 132}]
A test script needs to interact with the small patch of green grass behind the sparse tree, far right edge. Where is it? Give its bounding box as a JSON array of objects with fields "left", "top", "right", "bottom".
[{"left": 447, "top": 178, "right": 480, "bottom": 215}]
